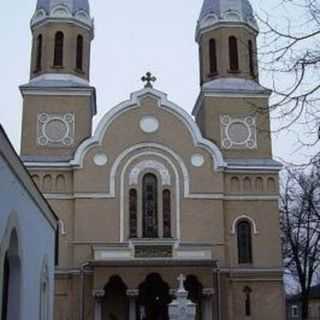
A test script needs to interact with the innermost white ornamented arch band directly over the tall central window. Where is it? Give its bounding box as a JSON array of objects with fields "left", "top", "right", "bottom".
[{"left": 129, "top": 160, "right": 171, "bottom": 186}]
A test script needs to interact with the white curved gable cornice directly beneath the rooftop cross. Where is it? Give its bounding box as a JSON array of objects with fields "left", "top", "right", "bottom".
[{"left": 71, "top": 88, "right": 226, "bottom": 170}]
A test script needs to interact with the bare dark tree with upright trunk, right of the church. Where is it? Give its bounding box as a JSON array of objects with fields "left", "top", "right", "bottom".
[{"left": 280, "top": 163, "right": 320, "bottom": 319}]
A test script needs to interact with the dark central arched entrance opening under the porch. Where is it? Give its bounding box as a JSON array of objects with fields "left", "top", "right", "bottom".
[{"left": 137, "top": 274, "right": 171, "bottom": 320}]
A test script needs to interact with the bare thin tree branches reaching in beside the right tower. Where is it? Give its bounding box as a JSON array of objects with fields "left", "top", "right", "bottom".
[{"left": 258, "top": 0, "right": 320, "bottom": 155}]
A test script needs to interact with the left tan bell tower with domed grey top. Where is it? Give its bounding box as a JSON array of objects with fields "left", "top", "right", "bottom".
[{"left": 20, "top": 0, "right": 96, "bottom": 161}]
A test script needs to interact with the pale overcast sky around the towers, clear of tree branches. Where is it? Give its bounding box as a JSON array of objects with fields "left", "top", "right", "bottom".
[{"left": 0, "top": 0, "right": 316, "bottom": 161}]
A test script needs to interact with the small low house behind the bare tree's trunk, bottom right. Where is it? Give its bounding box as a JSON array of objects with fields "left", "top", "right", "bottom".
[{"left": 287, "top": 284, "right": 320, "bottom": 320}]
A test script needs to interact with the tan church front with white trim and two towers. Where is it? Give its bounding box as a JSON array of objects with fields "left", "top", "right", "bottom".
[{"left": 21, "top": 0, "right": 285, "bottom": 320}]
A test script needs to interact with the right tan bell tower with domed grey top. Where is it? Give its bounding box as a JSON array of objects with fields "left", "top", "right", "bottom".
[{"left": 193, "top": 0, "right": 272, "bottom": 159}]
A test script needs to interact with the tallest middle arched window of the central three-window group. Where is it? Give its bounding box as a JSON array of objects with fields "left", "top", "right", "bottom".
[{"left": 142, "top": 174, "right": 158, "bottom": 238}]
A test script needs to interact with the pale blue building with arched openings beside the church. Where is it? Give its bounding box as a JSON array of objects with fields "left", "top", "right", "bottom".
[{"left": 0, "top": 126, "right": 58, "bottom": 320}]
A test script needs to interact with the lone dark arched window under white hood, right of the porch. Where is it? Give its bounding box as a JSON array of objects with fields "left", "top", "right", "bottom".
[{"left": 237, "top": 221, "right": 252, "bottom": 264}]
